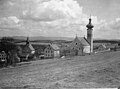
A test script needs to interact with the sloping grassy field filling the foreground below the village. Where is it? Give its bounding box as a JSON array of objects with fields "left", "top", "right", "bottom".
[{"left": 0, "top": 52, "right": 120, "bottom": 89}]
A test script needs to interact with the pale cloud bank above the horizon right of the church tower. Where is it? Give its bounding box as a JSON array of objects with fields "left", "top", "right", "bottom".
[{"left": 94, "top": 18, "right": 120, "bottom": 39}]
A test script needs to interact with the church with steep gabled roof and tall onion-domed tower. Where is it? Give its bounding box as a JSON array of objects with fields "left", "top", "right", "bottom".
[{"left": 69, "top": 18, "right": 94, "bottom": 55}]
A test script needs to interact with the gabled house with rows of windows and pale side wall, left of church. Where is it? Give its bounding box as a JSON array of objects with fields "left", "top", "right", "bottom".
[{"left": 44, "top": 44, "right": 60, "bottom": 58}]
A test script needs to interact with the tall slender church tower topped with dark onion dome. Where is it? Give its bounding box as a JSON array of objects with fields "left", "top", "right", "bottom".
[{"left": 86, "top": 18, "right": 94, "bottom": 53}]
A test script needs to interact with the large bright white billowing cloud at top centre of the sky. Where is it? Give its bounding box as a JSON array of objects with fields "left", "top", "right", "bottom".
[{"left": 23, "top": 0, "right": 82, "bottom": 21}]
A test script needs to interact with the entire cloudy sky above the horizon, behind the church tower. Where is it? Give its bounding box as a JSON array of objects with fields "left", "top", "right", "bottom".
[{"left": 0, "top": 0, "right": 120, "bottom": 39}]
